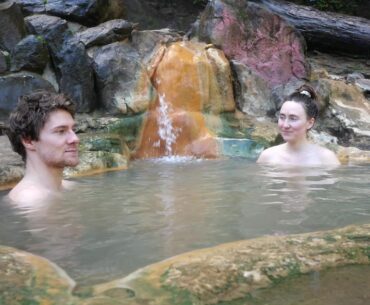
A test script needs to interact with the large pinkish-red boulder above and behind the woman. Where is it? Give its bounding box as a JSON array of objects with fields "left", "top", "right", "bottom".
[{"left": 196, "top": 0, "right": 309, "bottom": 87}]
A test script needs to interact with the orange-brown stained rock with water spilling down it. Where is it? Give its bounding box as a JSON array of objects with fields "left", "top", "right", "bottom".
[{"left": 135, "top": 41, "right": 235, "bottom": 158}]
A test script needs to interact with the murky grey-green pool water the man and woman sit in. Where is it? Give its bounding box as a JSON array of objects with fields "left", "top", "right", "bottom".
[{"left": 0, "top": 157, "right": 370, "bottom": 284}]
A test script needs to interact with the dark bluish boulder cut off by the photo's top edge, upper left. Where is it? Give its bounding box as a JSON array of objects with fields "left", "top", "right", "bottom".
[{"left": 17, "top": 0, "right": 124, "bottom": 26}]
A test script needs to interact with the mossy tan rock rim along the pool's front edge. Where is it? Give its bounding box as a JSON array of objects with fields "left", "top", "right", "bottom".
[{"left": 0, "top": 224, "right": 370, "bottom": 305}]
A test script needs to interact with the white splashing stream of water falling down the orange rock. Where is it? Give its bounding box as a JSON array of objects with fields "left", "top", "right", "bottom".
[{"left": 158, "top": 94, "right": 178, "bottom": 156}]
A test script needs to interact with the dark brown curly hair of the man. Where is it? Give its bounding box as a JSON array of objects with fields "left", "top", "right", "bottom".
[{"left": 6, "top": 90, "right": 75, "bottom": 161}]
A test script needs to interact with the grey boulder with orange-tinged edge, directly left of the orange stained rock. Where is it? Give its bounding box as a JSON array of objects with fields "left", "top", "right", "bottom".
[{"left": 89, "top": 41, "right": 155, "bottom": 114}]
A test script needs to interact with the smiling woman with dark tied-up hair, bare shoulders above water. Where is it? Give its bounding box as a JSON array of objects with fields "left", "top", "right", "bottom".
[{"left": 257, "top": 85, "right": 340, "bottom": 166}]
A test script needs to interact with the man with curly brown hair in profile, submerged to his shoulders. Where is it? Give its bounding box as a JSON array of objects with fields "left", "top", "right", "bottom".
[{"left": 7, "top": 91, "right": 79, "bottom": 203}]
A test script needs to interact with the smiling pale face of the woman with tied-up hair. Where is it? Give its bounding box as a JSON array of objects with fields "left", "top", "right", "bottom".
[{"left": 278, "top": 101, "right": 315, "bottom": 143}]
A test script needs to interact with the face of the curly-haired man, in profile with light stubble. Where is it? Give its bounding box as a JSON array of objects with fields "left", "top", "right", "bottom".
[{"left": 34, "top": 109, "right": 80, "bottom": 168}]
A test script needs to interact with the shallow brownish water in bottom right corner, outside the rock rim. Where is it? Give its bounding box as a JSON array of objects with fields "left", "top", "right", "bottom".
[{"left": 247, "top": 266, "right": 370, "bottom": 305}]
